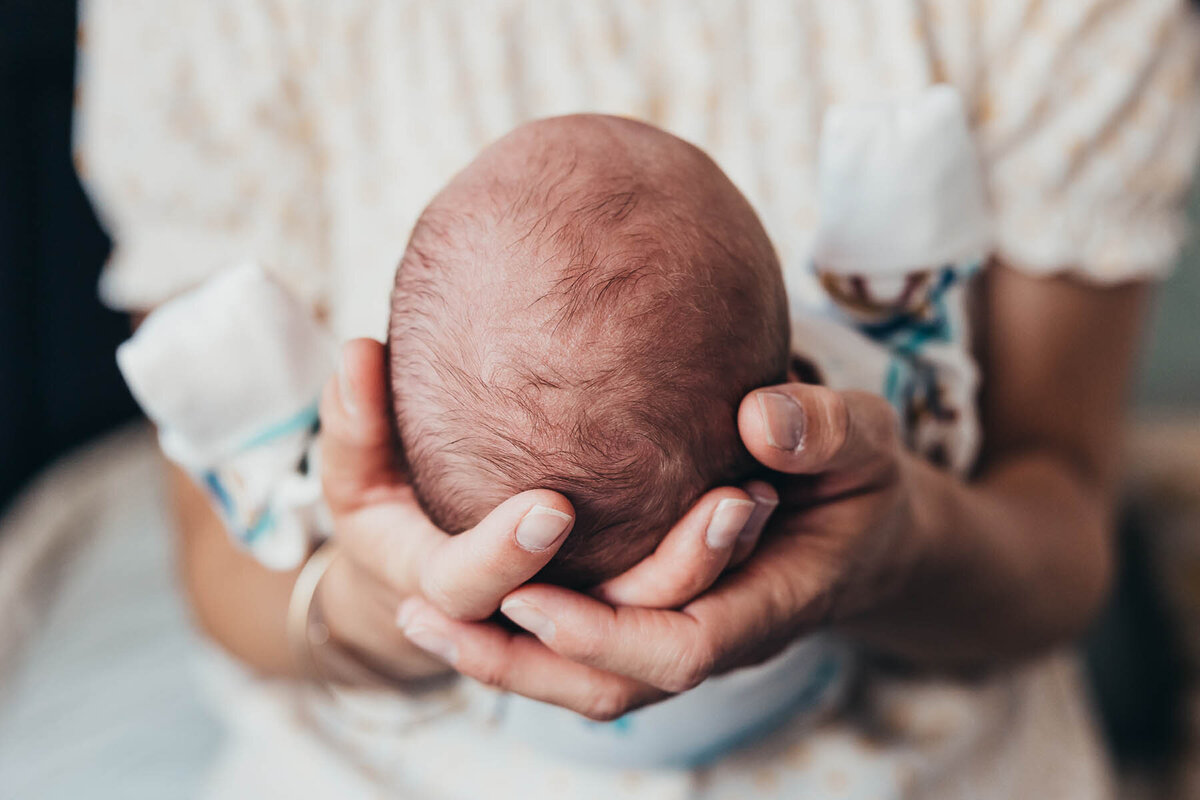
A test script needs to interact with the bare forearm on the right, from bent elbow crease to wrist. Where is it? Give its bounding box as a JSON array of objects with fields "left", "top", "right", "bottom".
[{"left": 847, "top": 451, "right": 1114, "bottom": 668}]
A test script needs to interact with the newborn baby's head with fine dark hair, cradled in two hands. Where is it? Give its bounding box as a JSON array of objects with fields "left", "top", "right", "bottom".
[{"left": 388, "top": 115, "right": 787, "bottom": 587}]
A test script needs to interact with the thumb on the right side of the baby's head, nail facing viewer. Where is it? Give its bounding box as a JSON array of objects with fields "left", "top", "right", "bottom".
[{"left": 738, "top": 384, "right": 899, "bottom": 475}]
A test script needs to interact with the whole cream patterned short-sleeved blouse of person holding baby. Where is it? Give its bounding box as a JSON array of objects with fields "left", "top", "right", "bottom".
[{"left": 76, "top": 0, "right": 1200, "bottom": 799}]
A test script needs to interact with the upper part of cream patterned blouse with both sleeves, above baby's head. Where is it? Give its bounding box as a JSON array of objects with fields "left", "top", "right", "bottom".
[{"left": 76, "top": 0, "right": 1200, "bottom": 338}]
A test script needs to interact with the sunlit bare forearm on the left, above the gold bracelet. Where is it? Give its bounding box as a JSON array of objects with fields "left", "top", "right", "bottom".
[{"left": 169, "top": 465, "right": 309, "bottom": 676}]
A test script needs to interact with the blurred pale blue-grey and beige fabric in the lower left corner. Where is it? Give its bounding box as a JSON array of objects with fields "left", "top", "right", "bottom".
[{"left": 0, "top": 425, "right": 221, "bottom": 800}]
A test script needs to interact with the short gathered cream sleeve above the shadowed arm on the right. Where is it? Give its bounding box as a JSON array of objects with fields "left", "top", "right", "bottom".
[{"left": 974, "top": 0, "right": 1200, "bottom": 283}]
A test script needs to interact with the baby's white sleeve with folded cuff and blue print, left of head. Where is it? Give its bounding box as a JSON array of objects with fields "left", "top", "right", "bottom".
[{"left": 116, "top": 263, "right": 334, "bottom": 570}]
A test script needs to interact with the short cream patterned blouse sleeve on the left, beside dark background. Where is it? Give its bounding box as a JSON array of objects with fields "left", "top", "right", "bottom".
[{"left": 76, "top": 0, "right": 328, "bottom": 311}]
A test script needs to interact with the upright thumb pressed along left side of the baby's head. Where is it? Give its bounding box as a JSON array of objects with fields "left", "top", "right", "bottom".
[{"left": 320, "top": 338, "right": 402, "bottom": 513}]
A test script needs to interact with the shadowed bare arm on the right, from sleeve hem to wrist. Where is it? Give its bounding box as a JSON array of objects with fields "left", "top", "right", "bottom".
[{"left": 856, "top": 265, "right": 1147, "bottom": 666}]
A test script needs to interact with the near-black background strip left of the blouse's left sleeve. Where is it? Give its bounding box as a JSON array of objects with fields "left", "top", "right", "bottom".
[{"left": 0, "top": 0, "right": 134, "bottom": 509}]
